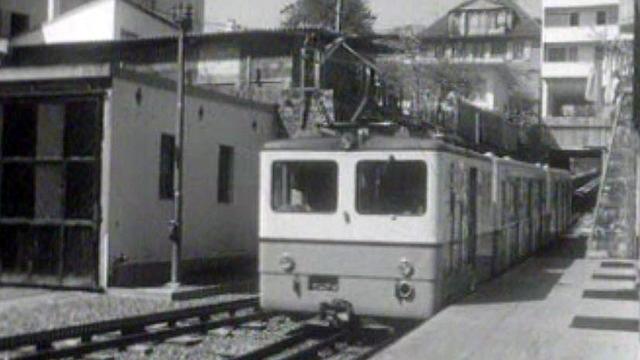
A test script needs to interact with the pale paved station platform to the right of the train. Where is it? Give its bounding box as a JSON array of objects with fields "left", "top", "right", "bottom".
[{"left": 374, "top": 231, "right": 640, "bottom": 360}]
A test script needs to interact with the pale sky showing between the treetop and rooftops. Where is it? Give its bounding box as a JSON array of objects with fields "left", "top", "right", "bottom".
[{"left": 205, "top": 0, "right": 541, "bottom": 32}]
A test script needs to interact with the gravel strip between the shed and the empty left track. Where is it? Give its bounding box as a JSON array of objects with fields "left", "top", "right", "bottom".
[{"left": 0, "top": 288, "right": 255, "bottom": 337}]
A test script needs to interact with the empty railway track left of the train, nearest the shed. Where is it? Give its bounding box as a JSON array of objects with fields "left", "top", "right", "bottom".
[{"left": 0, "top": 297, "right": 266, "bottom": 359}]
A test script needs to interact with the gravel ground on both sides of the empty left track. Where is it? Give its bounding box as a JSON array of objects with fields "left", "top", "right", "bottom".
[{"left": 0, "top": 288, "right": 410, "bottom": 360}]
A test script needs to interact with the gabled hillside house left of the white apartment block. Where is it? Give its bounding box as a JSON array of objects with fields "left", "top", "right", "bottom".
[{"left": 410, "top": 0, "right": 540, "bottom": 112}]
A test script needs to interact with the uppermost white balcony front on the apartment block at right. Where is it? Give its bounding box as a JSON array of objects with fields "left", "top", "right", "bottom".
[{"left": 542, "top": 24, "right": 620, "bottom": 44}]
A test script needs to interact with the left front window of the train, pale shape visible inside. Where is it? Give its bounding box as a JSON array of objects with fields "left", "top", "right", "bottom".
[{"left": 271, "top": 161, "right": 338, "bottom": 213}]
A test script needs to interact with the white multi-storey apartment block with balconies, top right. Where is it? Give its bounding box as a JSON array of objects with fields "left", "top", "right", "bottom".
[{"left": 542, "top": 0, "right": 620, "bottom": 117}]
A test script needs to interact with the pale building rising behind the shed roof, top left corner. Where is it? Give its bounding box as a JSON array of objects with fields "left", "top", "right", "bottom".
[{"left": 0, "top": 0, "right": 204, "bottom": 45}]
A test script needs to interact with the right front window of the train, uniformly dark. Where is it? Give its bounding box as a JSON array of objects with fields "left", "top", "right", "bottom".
[{"left": 356, "top": 160, "right": 427, "bottom": 215}]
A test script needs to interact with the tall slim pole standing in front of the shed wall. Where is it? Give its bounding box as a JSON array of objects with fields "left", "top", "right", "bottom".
[{"left": 168, "top": 3, "right": 193, "bottom": 288}]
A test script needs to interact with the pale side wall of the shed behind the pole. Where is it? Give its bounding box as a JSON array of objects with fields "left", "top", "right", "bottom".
[{"left": 104, "top": 73, "right": 276, "bottom": 284}]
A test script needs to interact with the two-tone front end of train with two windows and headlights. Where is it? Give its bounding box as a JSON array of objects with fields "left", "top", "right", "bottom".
[{"left": 259, "top": 139, "right": 439, "bottom": 319}]
